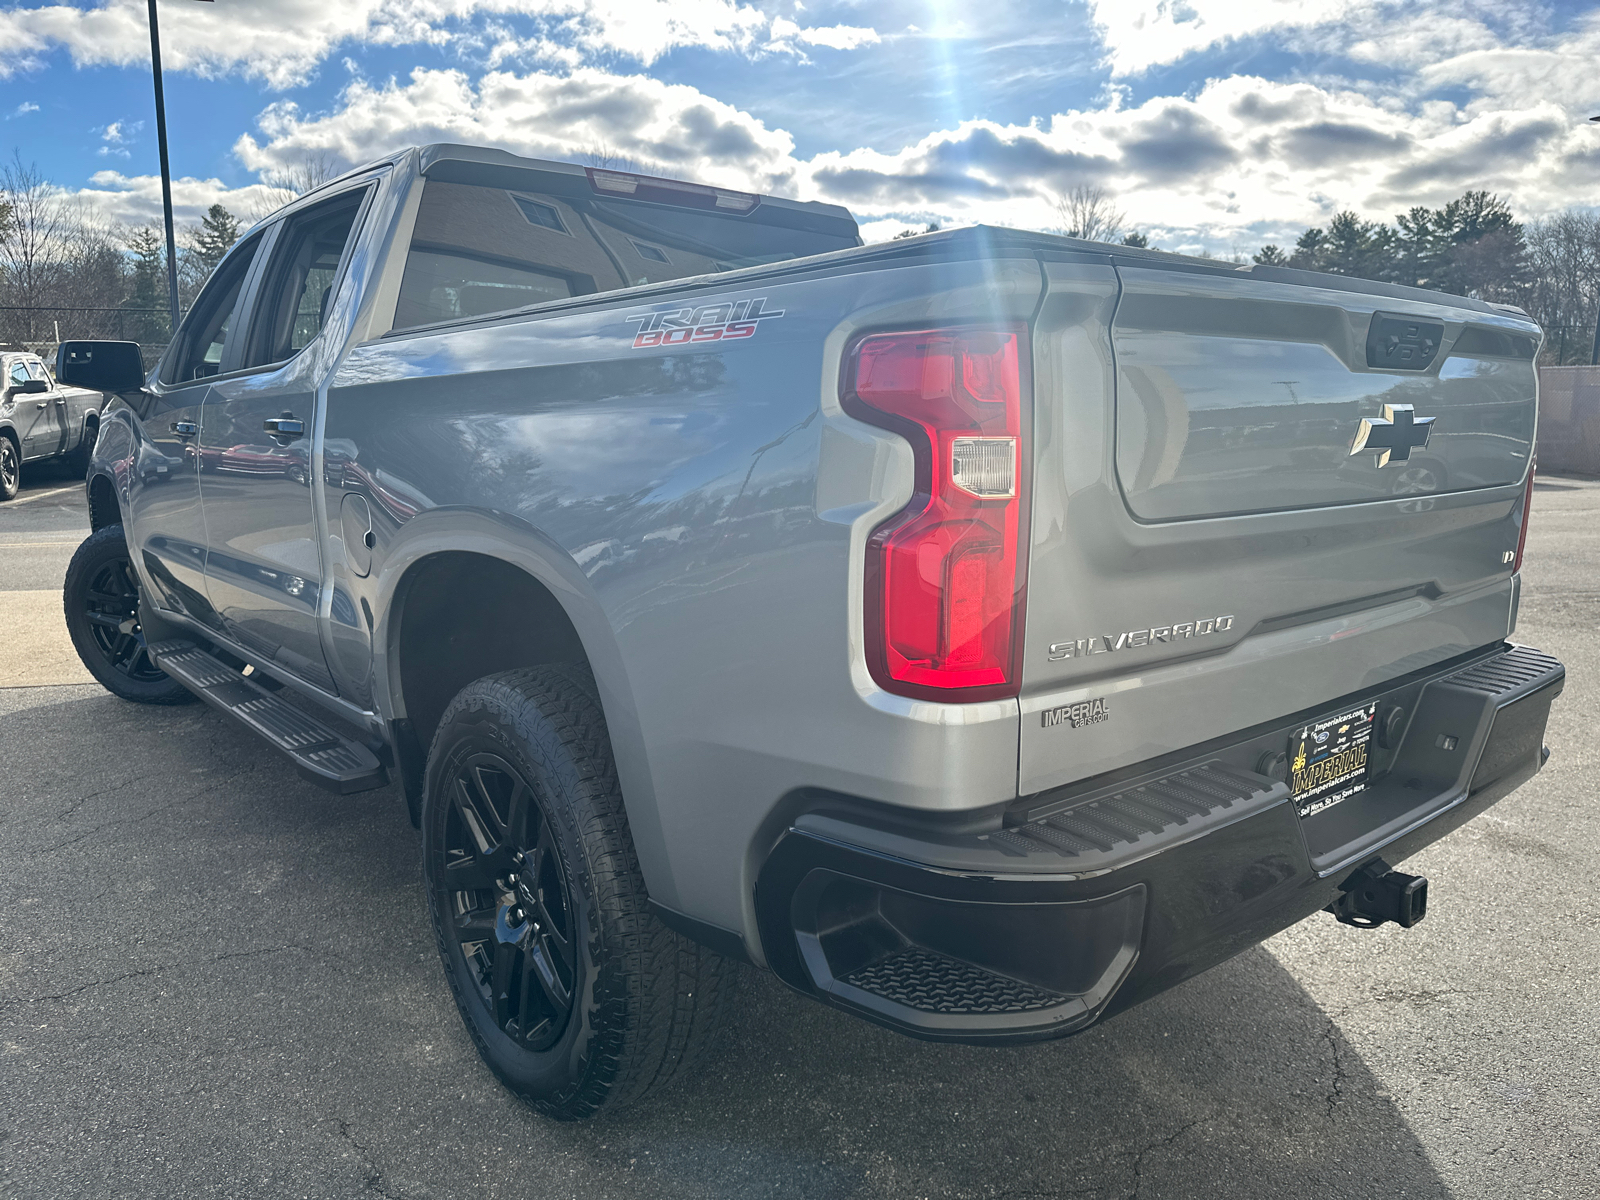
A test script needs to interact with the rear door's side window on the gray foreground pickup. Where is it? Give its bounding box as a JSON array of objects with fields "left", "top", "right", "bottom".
[{"left": 243, "top": 190, "right": 366, "bottom": 366}]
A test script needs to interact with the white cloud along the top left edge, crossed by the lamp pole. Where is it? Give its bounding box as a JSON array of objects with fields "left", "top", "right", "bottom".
[{"left": 0, "top": 0, "right": 877, "bottom": 88}]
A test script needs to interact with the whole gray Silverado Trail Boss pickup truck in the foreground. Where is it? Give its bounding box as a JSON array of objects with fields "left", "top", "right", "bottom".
[{"left": 59, "top": 146, "right": 1565, "bottom": 1117}]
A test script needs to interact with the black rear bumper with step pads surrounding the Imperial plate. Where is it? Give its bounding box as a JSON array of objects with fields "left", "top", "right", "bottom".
[{"left": 755, "top": 645, "right": 1566, "bottom": 1042}]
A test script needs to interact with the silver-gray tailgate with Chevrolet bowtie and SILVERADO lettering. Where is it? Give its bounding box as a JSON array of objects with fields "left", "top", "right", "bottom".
[{"left": 1019, "top": 259, "right": 1539, "bottom": 794}]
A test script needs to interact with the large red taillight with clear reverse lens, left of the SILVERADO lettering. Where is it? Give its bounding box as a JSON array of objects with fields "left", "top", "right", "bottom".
[{"left": 845, "top": 328, "right": 1029, "bottom": 701}]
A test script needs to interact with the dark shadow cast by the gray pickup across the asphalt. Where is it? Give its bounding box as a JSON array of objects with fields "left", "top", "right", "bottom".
[{"left": 0, "top": 688, "right": 1450, "bottom": 1200}]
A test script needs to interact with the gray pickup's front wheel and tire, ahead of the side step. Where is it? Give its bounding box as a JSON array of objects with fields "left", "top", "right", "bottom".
[{"left": 61, "top": 525, "right": 194, "bottom": 704}]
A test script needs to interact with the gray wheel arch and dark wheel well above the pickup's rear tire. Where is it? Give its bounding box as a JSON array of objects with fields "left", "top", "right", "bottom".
[{"left": 373, "top": 509, "right": 666, "bottom": 883}]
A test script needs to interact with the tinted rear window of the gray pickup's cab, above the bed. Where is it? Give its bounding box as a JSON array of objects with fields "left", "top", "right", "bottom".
[{"left": 394, "top": 179, "right": 859, "bottom": 330}]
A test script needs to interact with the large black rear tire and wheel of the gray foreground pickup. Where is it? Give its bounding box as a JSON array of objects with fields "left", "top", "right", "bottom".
[{"left": 422, "top": 666, "right": 736, "bottom": 1120}]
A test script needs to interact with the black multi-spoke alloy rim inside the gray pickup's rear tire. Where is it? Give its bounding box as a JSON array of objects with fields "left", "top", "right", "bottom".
[{"left": 442, "top": 752, "right": 578, "bottom": 1051}]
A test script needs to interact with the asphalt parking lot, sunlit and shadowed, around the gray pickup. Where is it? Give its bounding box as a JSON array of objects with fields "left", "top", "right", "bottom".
[{"left": 0, "top": 470, "right": 1600, "bottom": 1200}]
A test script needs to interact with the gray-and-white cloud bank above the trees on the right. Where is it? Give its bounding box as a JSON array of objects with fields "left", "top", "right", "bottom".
[{"left": 812, "top": 77, "right": 1600, "bottom": 250}]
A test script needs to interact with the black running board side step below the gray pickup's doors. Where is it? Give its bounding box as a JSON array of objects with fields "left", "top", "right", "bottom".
[{"left": 146, "top": 640, "right": 389, "bottom": 795}]
